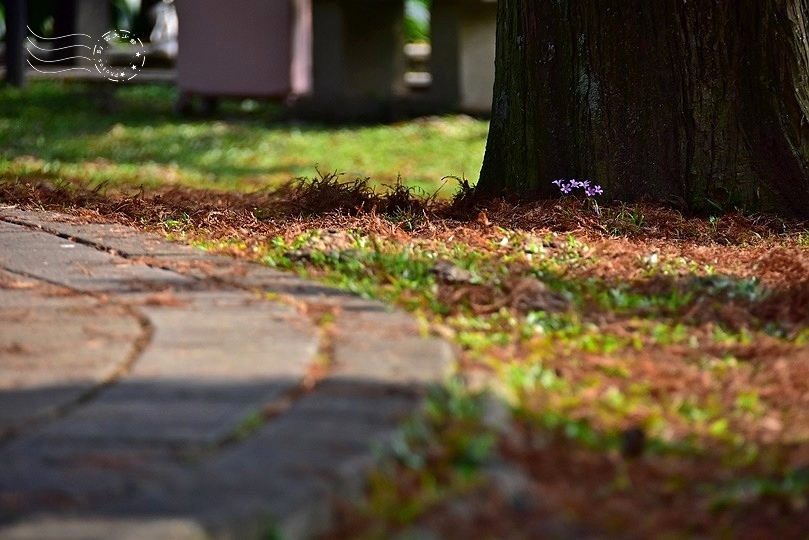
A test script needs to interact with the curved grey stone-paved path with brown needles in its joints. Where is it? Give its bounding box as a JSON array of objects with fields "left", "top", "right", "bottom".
[{"left": 0, "top": 206, "right": 453, "bottom": 540}]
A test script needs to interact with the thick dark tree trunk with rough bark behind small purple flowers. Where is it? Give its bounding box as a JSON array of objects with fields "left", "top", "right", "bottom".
[{"left": 476, "top": 0, "right": 809, "bottom": 217}]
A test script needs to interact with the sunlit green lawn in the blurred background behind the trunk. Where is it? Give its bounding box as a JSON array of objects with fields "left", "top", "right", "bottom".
[{"left": 0, "top": 81, "right": 488, "bottom": 196}]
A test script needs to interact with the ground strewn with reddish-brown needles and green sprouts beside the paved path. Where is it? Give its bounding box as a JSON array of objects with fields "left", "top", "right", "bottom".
[{"left": 0, "top": 174, "right": 809, "bottom": 538}]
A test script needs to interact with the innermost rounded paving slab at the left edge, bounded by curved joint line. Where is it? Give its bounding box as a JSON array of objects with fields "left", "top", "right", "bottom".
[{"left": 0, "top": 270, "right": 146, "bottom": 434}]
